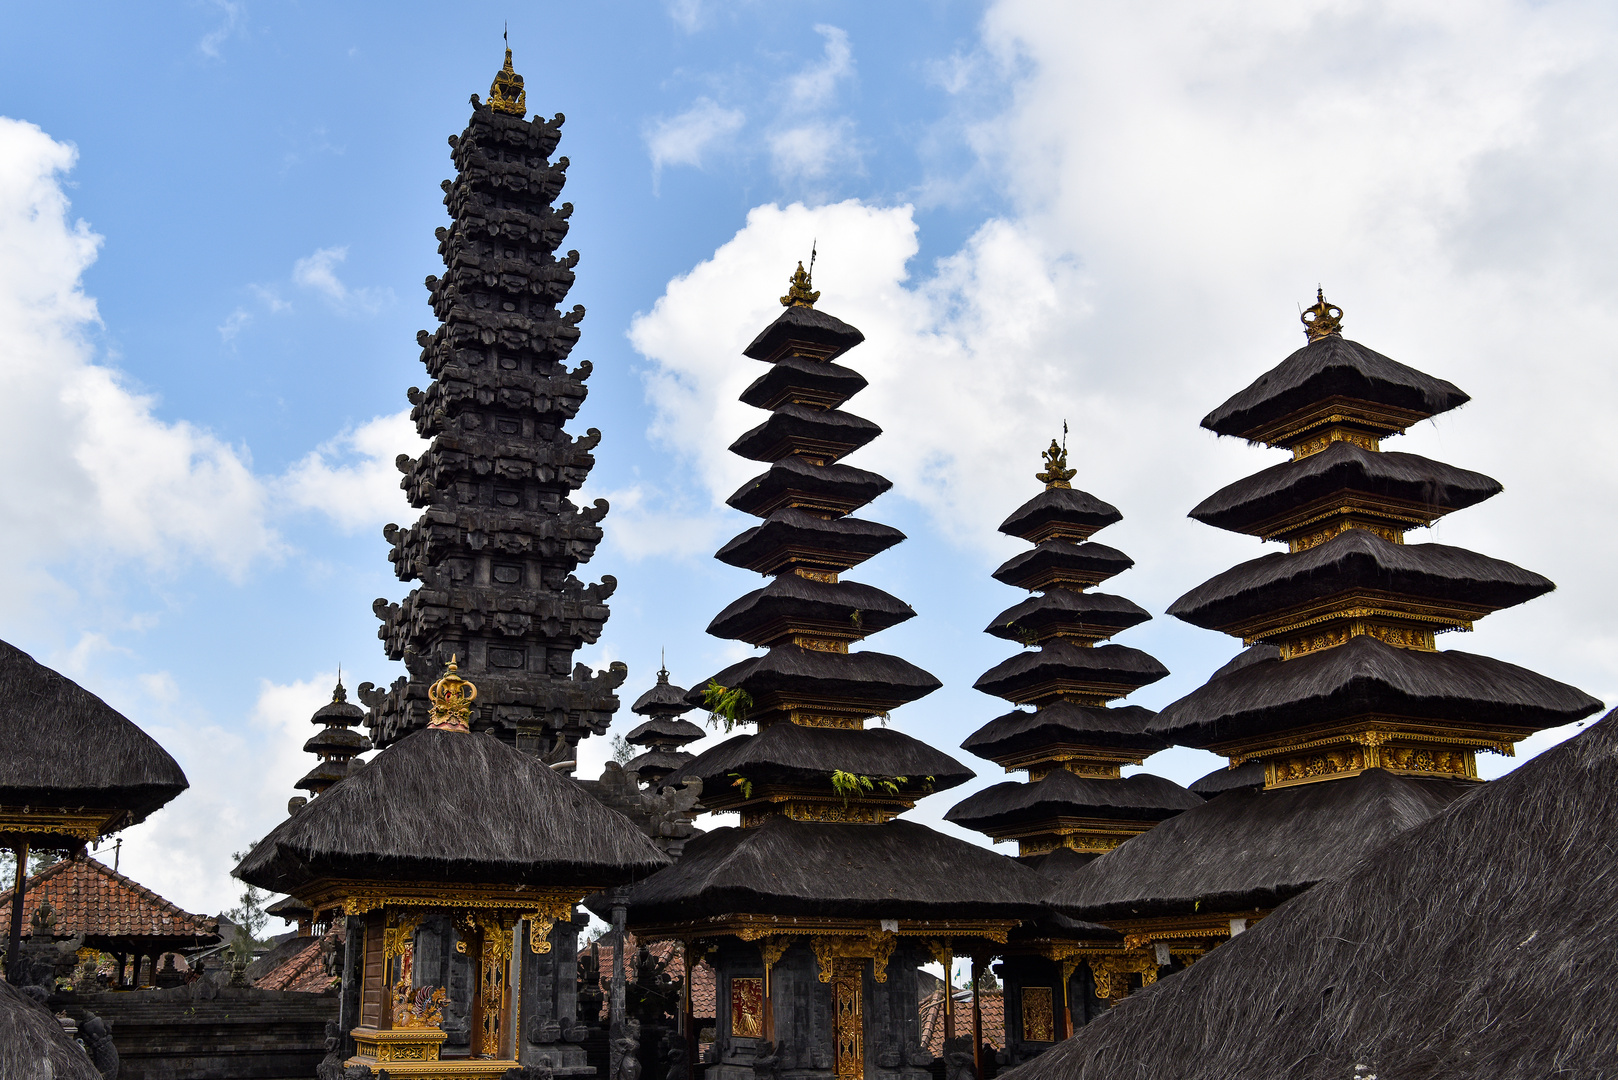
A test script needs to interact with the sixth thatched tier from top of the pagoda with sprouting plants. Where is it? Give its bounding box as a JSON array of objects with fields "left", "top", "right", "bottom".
[{"left": 709, "top": 573, "right": 916, "bottom": 644}]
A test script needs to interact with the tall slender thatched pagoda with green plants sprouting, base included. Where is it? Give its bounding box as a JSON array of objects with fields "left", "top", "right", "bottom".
[{"left": 629, "top": 264, "right": 1080, "bottom": 1080}]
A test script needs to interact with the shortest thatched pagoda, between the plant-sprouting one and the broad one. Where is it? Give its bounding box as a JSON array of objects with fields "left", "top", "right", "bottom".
[{"left": 945, "top": 440, "right": 1202, "bottom": 870}]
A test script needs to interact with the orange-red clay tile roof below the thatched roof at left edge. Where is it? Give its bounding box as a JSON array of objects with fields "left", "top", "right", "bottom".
[{"left": 0, "top": 857, "right": 218, "bottom": 946}]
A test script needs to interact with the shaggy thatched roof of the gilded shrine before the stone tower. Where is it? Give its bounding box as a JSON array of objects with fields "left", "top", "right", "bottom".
[{"left": 235, "top": 729, "right": 668, "bottom": 892}]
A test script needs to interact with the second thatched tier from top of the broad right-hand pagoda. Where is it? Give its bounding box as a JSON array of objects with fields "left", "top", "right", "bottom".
[{"left": 1191, "top": 442, "right": 1502, "bottom": 533}]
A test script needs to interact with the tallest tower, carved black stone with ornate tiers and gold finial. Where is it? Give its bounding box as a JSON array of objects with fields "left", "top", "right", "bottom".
[{"left": 361, "top": 52, "right": 626, "bottom": 763}]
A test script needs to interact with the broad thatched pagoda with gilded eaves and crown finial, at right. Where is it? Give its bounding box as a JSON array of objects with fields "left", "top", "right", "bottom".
[{"left": 1057, "top": 293, "right": 1600, "bottom": 981}]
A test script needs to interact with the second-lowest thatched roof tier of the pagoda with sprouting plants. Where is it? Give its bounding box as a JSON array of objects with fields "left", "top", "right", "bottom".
[{"left": 684, "top": 724, "right": 974, "bottom": 795}]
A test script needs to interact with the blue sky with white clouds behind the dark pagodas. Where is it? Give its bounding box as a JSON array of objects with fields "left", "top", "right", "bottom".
[{"left": 0, "top": 0, "right": 1618, "bottom": 912}]
